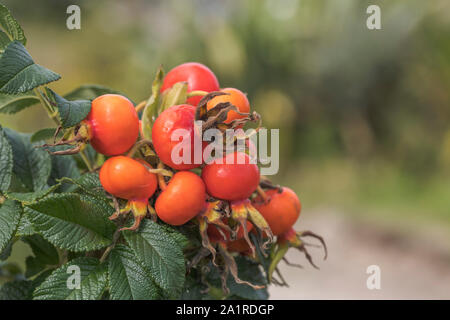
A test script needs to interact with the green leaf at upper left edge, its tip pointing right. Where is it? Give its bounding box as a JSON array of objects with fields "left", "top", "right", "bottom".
[{"left": 0, "top": 41, "right": 61, "bottom": 94}]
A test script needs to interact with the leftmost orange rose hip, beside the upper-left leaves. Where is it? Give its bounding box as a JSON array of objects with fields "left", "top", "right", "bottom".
[{"left": 83, "top": 94, "right": 139, "bottom": 156}]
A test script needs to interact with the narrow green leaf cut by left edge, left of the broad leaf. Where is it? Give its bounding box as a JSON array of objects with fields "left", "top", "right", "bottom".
[{"left": 0, "top": 200, "right": 22, "bottom": 252}]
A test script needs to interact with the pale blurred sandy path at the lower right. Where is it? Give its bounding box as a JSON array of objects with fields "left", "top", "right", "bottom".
[{"left": 270, "top": 210, "right": 450, "bottom": 299}]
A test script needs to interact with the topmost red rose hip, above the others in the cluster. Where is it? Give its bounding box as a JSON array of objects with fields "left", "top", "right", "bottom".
[{"left": 161, "top": 62, "right": 220, "bottom": 106}]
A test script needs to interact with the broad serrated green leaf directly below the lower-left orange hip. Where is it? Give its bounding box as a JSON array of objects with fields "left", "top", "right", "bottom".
[{"left": 27, "top": 193, "right": 115, "bottom": 252}]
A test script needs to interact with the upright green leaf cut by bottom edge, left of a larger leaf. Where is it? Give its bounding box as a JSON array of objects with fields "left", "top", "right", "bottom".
[{"left": 108, "top": 244, "right": 160, "bottom": 300}]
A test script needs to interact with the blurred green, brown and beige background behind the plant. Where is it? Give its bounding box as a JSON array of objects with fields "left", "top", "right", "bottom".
[{"left": 0, "top": 0, "right": 450, "bottom": 299}]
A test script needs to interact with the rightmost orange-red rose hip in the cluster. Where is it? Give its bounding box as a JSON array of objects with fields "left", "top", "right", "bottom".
[{"left": 252, "top": 187, "right": 302, "bottom": 236}]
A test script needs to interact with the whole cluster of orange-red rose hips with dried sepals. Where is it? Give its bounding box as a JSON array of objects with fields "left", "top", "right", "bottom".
[{"left": 60, "top": 63, "right": 322, "bottom": 288}]
